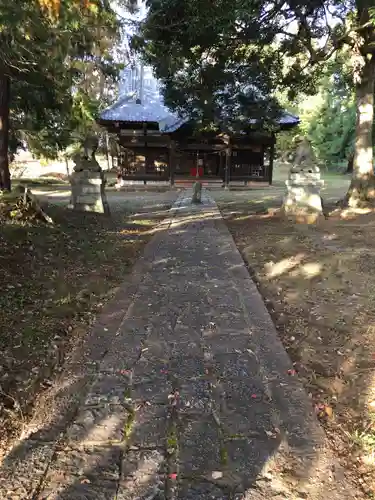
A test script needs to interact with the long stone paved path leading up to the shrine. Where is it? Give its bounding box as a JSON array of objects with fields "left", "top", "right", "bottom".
[{"left": 0, "top": 191, "right": 364, "bottom": 500}]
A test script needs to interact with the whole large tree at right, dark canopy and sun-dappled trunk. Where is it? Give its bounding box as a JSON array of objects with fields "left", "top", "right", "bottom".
[{"left": 134, "top": 0, "right": 375, "bottom": 205}]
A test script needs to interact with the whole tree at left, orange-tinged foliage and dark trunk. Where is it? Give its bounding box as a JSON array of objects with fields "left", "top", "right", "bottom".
[{"left": 0, "top": 0, "right": 125, "bottom": 190}]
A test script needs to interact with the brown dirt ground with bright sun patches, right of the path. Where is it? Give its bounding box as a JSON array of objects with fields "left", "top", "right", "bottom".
[{"left": 214, "top": 170, "right": 375, "bottom": 498}]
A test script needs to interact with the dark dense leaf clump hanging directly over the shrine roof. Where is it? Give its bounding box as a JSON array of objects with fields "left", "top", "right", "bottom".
[{"left": 133, "top": 0, "right": 290, "bottom": 130}]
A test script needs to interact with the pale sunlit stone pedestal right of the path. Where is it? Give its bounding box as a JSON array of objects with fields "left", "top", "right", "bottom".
[{"left": 283, "top": 166, "right": 324, "bottom": 223}]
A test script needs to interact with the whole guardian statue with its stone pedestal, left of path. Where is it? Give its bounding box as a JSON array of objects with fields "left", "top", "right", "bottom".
[{"left": 69, "top": 137, "right": 109, "bottom": 213}]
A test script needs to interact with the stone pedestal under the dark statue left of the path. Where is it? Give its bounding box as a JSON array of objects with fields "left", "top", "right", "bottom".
[{"left": 68, "top": 170, "right": 109, "bottom": 214}]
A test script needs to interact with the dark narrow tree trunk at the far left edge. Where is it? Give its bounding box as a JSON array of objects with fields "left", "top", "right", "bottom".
[{"left": 0, "top": 74, "right": 11, "bottom": 191}]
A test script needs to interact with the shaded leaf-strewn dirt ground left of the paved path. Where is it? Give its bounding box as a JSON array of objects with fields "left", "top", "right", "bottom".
[{"left": 0, "top": 192, "right": 177, "bottom": 458}]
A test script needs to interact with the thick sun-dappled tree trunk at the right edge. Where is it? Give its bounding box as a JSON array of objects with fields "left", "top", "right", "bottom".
[{"left": 346, "top": 57, "right": 375, "bottom": 207}]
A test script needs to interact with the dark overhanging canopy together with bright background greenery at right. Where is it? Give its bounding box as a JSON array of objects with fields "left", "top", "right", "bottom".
[{"left": 133, "top": 0, "right": 375, "bottom": 180}]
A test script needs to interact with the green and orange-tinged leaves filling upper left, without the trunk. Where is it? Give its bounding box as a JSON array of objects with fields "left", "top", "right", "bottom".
[{"left": 0, "top": 0, "right": 128, "bottom": 158}]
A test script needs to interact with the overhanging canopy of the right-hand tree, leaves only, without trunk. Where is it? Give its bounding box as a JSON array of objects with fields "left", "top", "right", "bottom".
[{"left": 133, "top": 0, "right": 362, "bottom": 129}]
